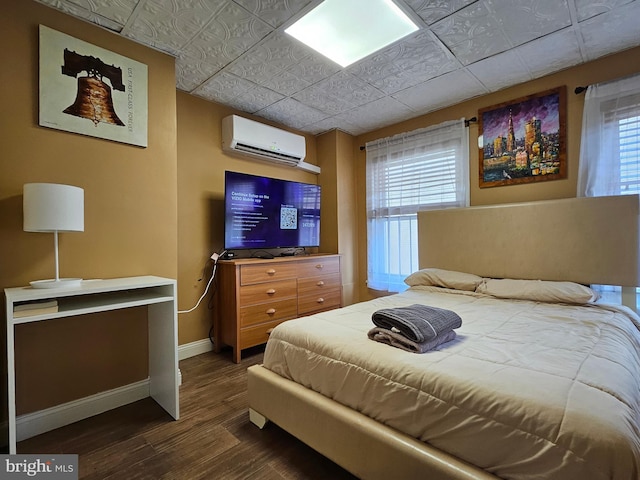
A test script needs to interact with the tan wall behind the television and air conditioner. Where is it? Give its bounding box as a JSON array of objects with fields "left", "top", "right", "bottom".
[{"left": 177, "top": 92, "right": 322, "bottom": 345}]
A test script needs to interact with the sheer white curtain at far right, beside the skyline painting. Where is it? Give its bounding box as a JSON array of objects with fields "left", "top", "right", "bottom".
[{"left": 578, "top": 75, "right": 640, "bottom": 197}]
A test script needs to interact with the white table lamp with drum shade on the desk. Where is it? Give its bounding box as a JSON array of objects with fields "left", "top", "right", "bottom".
[{"left": 22, "top": 183, "right": 84, "bottom": 288}]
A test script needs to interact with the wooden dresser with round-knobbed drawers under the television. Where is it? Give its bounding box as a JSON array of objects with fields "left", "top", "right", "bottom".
[{"left": 213, "top": 254, "right": 342, "bottom": 363}]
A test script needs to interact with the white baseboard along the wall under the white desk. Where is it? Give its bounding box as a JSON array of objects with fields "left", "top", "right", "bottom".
[{"left": 16, "top": 378, "right": 149, "bottom": 442}]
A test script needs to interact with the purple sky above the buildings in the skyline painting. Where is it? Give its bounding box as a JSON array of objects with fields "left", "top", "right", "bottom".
[{"left": 482, "top": 93, "right": 560, "bottom": 144}]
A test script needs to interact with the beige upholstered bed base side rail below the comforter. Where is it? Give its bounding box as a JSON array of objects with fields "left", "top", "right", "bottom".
[{"left": 248, "top": 365, "right": 497, "bottom": 480}]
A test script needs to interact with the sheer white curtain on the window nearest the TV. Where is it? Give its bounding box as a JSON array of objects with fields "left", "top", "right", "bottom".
[{"left": 366, "top": 119, "right": 469, "bottom": 292}]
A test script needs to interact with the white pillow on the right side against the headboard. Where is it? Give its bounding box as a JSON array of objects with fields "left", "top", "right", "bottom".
[{"left": 476, "top": 278, "right": 600, "bottom": 304}]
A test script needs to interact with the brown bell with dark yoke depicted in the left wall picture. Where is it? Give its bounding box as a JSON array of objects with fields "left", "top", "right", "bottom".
[{"left": 62, "top": 48, "right": 125, "bottom": 126}]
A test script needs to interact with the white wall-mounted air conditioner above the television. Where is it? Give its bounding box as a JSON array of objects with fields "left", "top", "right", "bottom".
[{"left": 222, "top": 115, "right": 320, "bottom": 173}]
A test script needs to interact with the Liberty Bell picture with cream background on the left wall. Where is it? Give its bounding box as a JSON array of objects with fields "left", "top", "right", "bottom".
[{"left": 39, "top": 25, "right": 148, "bottom": 147}]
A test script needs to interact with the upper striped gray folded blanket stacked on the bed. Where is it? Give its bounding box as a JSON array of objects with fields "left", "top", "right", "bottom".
[{"left": 371, "top": 304, "right": 462, "bottom": 343}]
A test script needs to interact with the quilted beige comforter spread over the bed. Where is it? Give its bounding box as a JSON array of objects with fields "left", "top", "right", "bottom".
[{"left": 264, "top": 287, "right": 640, "bottom": 480}]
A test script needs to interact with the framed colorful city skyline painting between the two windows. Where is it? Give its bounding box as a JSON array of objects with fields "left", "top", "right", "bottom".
[{"left": 478, "top": 86, "right": 567, "bottom": 188}]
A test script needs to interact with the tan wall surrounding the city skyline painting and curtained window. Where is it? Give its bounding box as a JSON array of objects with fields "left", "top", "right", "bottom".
[{"left": 354, "top": 48, "right": 640, "bottom": 300}]
